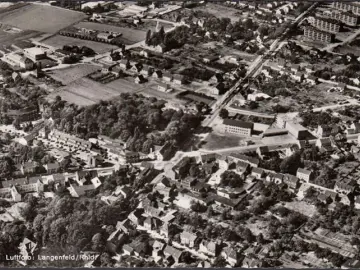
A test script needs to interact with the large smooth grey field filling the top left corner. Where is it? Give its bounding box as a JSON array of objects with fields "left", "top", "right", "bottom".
[{"left": 0, "top": 4, "right": 86, "bottom": 33}]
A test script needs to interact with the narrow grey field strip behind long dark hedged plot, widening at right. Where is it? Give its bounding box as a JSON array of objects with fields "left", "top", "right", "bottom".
[{"left": 74, "top": 22, "right": 146, "bottom": 45}]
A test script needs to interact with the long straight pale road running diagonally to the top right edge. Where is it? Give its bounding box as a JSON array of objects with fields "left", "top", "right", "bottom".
[{"left": 202, "top": 3, "right": 317, "bottom": 127}]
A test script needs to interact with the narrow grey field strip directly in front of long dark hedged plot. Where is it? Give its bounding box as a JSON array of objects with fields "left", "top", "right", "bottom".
[{"left": 42, "top": 35, "right": 118, "bottom": 54}]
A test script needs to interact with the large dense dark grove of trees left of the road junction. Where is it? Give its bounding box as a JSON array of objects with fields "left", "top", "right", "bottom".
[{"left": 47, "top": 94, "right": 201, "bottom": 153}]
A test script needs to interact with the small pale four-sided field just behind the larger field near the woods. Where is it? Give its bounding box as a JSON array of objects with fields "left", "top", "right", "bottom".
[{"left": 47, "top": 64, "right": 100, "bottom": 85}]
